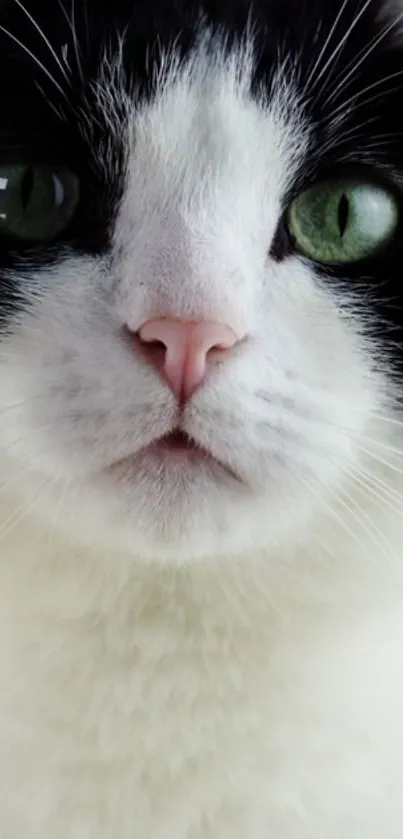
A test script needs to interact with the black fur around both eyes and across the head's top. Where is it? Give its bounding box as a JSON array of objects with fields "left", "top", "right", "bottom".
[{"left": 0, "top": 0, "right": 403, "bottom": 362}]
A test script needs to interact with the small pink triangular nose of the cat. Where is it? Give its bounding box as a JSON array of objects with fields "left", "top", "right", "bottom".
[{"left": 137, "top": 318, "right": 240, "bottom": 400}]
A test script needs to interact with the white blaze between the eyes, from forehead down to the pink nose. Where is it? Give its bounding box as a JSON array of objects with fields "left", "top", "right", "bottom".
[{"left": 103, "top": 36, "right": 309, "bottom": 331}]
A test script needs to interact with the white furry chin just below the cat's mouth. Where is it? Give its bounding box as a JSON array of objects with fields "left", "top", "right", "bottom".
[{"left": 64, "top": 451, "right": 256, "bottom": 565}]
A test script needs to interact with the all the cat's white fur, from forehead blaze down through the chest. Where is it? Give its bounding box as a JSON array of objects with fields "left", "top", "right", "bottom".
[{"left": 0, "top": 37, "right": 403, "bottom": 839}]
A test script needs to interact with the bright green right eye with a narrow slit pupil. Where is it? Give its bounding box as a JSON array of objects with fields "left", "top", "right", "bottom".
[{"left": 288, "top": 180, "right": 400, "bottom": 264}]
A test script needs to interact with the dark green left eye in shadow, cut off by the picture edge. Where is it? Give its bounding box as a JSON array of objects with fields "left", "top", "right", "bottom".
[{"left": 0, "top": 164, "right": 79, "bottom": 242}]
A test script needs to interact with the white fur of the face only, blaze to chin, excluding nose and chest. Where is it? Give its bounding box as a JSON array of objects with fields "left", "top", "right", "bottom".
[{"left": 0, "top": 26, "right": 376, "bottom": 560}]
